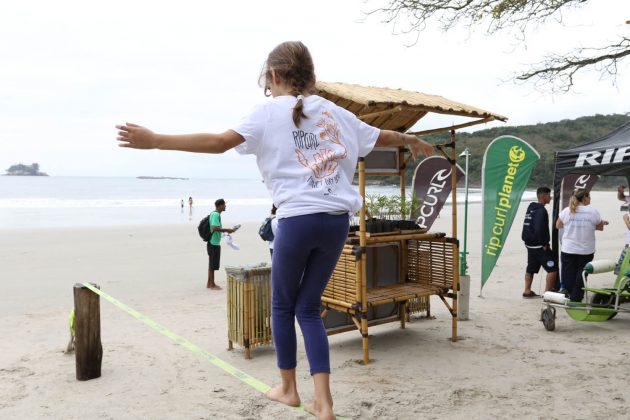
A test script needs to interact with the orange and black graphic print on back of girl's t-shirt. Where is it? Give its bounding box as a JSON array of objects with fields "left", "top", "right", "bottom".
[{"left": 293, "top": 111, "right": 348, "bottom": 195}]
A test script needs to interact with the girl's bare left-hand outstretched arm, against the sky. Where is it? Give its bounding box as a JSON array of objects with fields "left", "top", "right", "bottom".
[{"left": 116, "top": 123, "right": 245, "bottom": 153}]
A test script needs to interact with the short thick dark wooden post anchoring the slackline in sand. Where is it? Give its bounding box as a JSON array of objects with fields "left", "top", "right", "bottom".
[{"left": 74, "top": 283, "right": 103, "bottom": 381}]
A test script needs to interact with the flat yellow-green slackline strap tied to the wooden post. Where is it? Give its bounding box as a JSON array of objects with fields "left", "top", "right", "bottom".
[{"left": 83, "top": 283, "right": 343, "bottom": 419}]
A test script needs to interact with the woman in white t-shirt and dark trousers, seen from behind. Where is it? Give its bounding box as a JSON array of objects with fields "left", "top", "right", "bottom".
[{"left": 556, "top": 189, "right": 608, "bottom": 302}]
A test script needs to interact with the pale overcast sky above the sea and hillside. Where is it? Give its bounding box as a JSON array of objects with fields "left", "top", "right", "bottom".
[{"left": 0, "top": 0, "right": 630, "bottom": 178}]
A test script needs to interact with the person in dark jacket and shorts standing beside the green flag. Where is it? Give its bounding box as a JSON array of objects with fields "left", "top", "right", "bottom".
[{"left": 521, "top": 187, "right": 558, "bottom": 298}]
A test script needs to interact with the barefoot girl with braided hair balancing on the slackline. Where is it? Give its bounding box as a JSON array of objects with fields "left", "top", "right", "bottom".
[{"left": 117, "top": 42, "right": 433, "bottom": 419}]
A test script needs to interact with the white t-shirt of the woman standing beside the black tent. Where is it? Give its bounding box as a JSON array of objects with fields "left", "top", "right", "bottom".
[{"left": 558, "top": 205, "right": 602, "bottom": 255}]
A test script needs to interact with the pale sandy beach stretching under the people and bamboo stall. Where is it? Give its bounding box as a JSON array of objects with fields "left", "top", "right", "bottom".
[{"left": 0, "top": 191, "right": 630, "bottom": 419}]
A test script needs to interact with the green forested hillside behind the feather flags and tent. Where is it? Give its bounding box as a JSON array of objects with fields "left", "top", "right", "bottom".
[{"left": 400, "top": 113, "right": 630, "bottom": 188}]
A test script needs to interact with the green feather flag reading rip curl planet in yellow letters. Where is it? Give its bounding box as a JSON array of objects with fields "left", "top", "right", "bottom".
[{"left": 481, "top": 136, "right": 540, "bottom": 289}]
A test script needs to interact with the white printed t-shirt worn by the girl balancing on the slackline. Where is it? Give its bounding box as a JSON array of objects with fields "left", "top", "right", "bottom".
[{"left": 233, "top": 95, "right": 380, "bottom": 219}]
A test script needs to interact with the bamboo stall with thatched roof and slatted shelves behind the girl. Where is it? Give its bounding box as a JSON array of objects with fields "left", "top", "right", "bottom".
[{"left": 316, "top": 82, "right": 507, "bottom": 364}]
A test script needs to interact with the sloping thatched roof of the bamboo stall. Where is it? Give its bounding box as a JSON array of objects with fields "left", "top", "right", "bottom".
[{"left": 315, "top": 82, "right": 507, "bottom": 132}]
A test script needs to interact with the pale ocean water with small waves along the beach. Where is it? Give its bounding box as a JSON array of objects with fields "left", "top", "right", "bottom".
[{"left": 0, "top": 176, "right": 527, "bottom": 229}]
